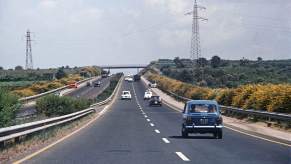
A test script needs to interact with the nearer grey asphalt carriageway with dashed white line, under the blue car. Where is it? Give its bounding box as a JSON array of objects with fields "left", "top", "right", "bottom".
[{"left": 24, "top": 79, "right": 291, "bottom": 164}]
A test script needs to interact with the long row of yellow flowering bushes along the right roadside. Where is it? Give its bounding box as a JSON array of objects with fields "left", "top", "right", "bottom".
[{"left": 146, "top": 74, "right": 291, "bottom": 113}]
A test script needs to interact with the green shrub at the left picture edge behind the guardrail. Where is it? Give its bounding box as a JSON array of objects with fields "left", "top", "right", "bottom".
[{"left": 0, "top": 88, "right": 20, "bottom": 127}]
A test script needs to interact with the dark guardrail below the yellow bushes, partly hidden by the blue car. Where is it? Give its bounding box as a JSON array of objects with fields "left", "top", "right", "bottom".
[{"left": 161, "top": 85, "right": 291, "bottom": 123}]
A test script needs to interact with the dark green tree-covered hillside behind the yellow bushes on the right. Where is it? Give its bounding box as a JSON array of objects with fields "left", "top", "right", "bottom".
[{"left": 152, "top": 56, "right": 291, "bottom": 88}]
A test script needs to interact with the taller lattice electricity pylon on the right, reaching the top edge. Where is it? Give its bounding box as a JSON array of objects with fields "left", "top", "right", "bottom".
[{"left": 185, "top": 0, "right": 207, "bottom": 84}]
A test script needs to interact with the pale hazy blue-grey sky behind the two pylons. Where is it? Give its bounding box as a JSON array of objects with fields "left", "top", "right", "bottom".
[{"left": 0, "top": 0, "right": 291, "bottom": 68}]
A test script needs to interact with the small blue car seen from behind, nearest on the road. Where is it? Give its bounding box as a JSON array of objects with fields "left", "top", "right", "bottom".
[{"left": 182, "top": 100, "right": 223, "bottom": 139}]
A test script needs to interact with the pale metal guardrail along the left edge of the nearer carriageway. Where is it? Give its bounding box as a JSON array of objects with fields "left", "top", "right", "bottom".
[{"left": 0, "top": 77, "right": 122, "bottom": 147}]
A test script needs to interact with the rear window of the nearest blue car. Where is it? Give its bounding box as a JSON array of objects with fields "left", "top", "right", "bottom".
[{"left": 189, "top": 104, "right": 217, "bottom": 113}]
